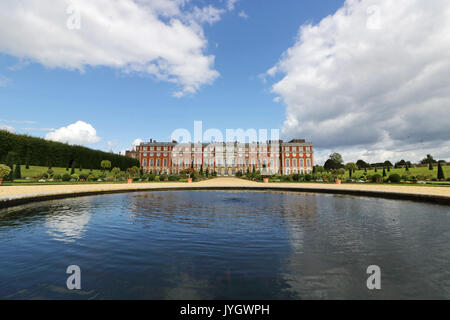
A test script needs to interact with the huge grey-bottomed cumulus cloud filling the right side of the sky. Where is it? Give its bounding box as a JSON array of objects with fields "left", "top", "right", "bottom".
[{"left": 267, "top": 0, "right": 450, "bottom": 164}]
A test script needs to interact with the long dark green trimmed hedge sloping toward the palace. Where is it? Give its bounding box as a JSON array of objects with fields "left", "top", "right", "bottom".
[{"left": 0, "top": 130, "right": 139, "bottom": 171}]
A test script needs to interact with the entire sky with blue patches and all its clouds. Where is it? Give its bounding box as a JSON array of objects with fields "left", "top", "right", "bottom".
[{"left": 0, "top": 0, "right": 450, "bottom": 163}]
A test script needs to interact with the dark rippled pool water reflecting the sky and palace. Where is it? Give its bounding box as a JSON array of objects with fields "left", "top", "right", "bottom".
[{"left": 0, "top": 191, "right": 450, "bottom": 299}]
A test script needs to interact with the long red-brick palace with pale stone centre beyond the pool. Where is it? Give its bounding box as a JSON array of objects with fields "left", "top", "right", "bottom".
[{"left": 126, "top": 139, "right": 314, "bottom": 176}]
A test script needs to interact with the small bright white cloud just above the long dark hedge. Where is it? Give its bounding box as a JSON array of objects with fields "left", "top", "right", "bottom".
[{"left": 45, "top": 121, "right": 100, "bottom": 145}]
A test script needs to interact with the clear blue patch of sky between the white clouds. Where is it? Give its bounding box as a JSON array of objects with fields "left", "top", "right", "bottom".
[{"left": 0, "top": 0, "right": 343, "bottom": 151}]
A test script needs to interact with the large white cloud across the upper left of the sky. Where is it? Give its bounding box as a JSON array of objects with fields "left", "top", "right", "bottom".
[{"left": 0, "top": 0, "right": 222, "bottom": 95}]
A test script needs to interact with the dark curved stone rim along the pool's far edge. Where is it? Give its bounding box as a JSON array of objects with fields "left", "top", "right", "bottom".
[{"left": 0, "top": 185, "right": 450, "bottom": 209}]
